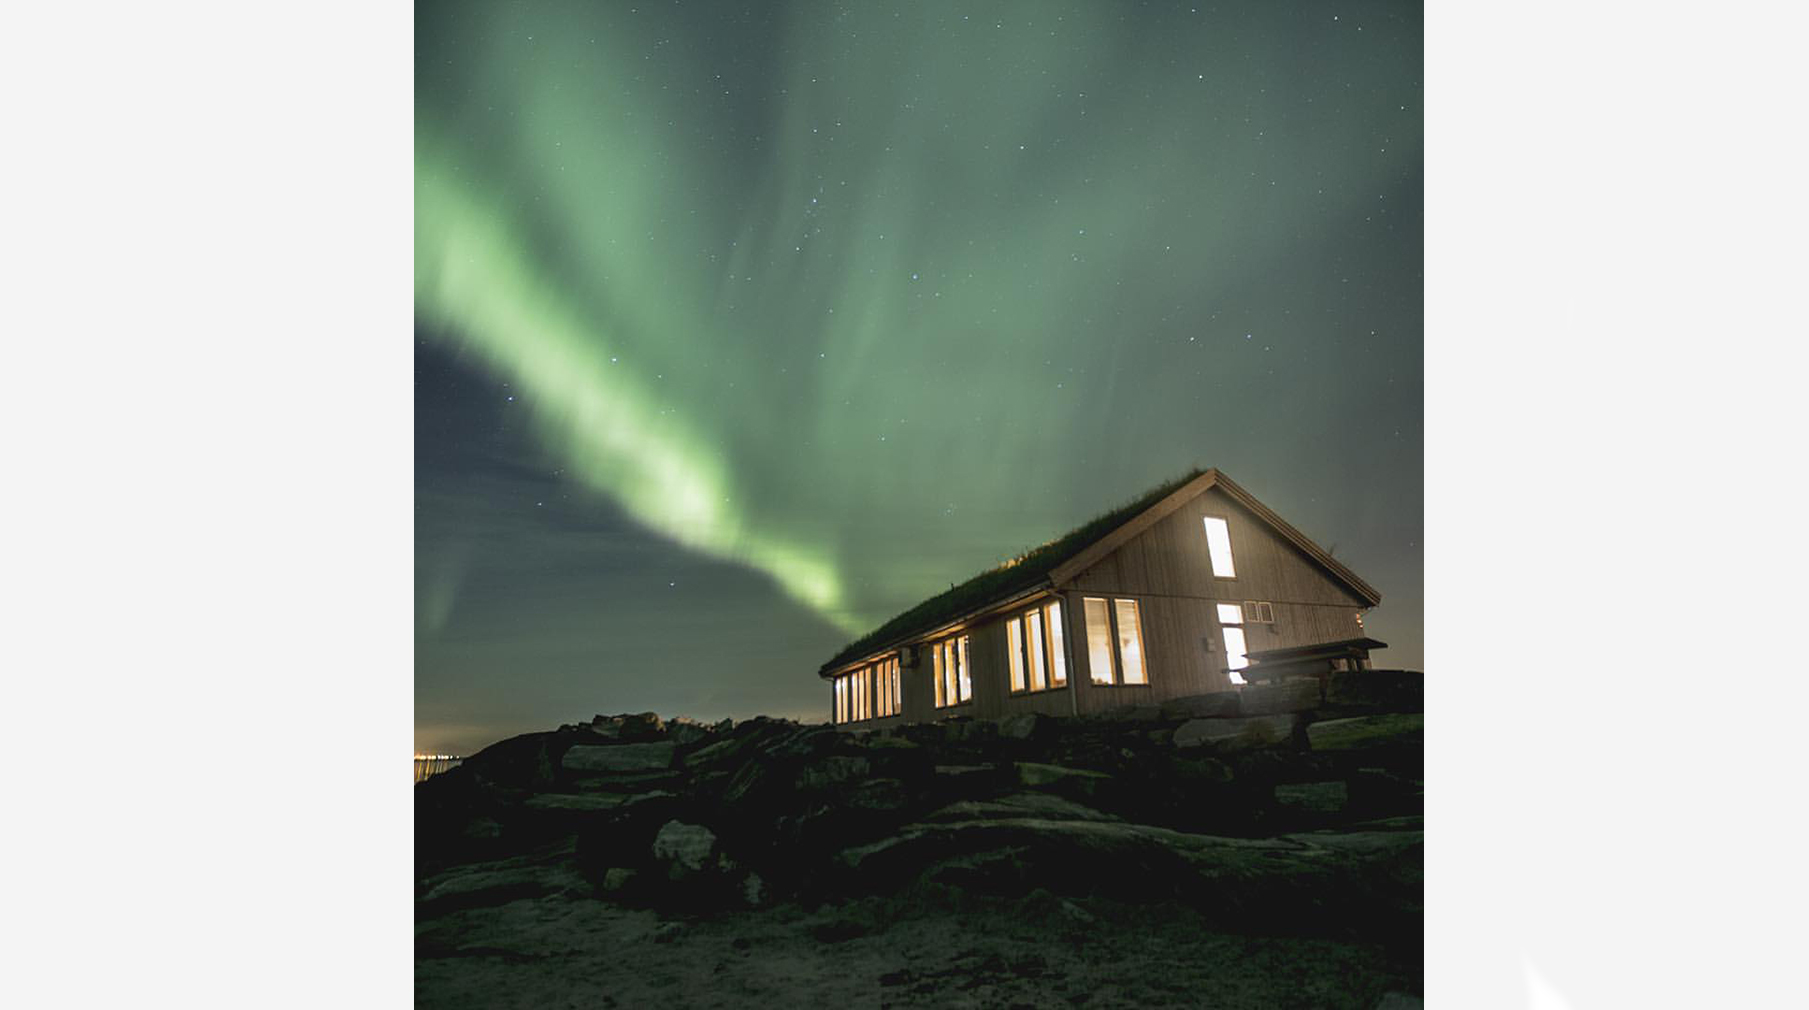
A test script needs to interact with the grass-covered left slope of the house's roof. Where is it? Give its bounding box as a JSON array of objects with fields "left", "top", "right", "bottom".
[{"left": 821, "top": 469, "right": 1205, "bottom": 673}]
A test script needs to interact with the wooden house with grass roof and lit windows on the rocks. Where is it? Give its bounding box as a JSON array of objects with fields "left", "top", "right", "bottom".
[{"left": 819, "top": 469, "right": 1382, "bottom": 729}]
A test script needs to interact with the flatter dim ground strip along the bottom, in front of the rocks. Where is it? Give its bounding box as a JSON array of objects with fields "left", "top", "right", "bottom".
[{"left": 414, "top": 883, "right": 1418, "bottom": 1010}]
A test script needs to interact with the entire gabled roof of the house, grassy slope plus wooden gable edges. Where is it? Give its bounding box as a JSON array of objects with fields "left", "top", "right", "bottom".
[{"left": 819, "top": 469, "right": 1382, "bottom": 675}]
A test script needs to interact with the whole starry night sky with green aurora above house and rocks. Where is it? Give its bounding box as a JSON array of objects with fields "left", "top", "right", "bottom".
[{"left": 414, "top": 2, "right": 1424, "bottom": 753}]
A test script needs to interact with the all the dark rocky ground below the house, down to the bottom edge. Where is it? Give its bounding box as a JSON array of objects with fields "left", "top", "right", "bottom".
[{"left": 416, "top": 672, "right": 1422, "bottom": 1008}]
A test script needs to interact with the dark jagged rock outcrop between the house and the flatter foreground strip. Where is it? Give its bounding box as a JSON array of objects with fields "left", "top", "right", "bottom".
[{"left": 416, "top": 675, "right": 1424, "bottom": 932}]
